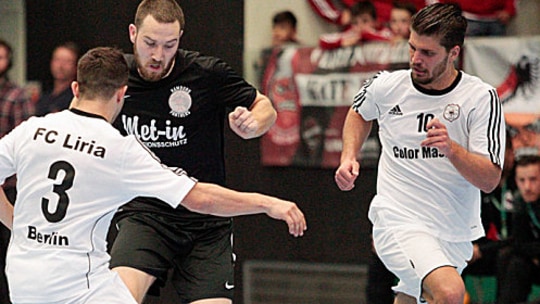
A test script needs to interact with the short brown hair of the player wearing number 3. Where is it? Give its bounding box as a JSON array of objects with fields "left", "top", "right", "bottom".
[{"left": 77, "top": 47, "right": 129, "bottom": 99}]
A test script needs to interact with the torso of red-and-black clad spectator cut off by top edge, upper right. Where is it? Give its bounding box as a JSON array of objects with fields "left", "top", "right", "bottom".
[{"left": 440, "top": 0, "right": 516, "bottom": 36}]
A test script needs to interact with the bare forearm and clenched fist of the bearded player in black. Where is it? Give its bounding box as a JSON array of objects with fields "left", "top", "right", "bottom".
[{"left": 229, "top": 91, "right": 277, "bottom": 139}]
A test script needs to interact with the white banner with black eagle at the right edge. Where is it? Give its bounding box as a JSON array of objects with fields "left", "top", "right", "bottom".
[{"left": 463, "top": 36, "right": 540, "bottom": 155}]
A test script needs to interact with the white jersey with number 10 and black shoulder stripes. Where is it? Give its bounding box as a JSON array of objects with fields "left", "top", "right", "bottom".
[{"left": 353, "top": 70, "right": 505, "bottom": 242}]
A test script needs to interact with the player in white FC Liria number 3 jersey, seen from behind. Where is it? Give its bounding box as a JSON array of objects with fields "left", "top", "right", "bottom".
[{"left": 0, "top": 48, "right": 306, "bottom": 304}]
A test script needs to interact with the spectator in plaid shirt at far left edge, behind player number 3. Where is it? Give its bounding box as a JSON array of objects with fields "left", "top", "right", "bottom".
[{"left": 0, "top": 39, "right": 34, "bottom": 303}]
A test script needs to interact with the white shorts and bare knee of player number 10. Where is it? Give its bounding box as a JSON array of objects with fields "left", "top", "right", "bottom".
[{"left": 372, "top": 211, "right": 472, "bottom": 304}]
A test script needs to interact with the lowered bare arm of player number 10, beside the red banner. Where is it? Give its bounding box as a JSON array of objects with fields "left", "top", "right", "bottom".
[{"left": 334, "top": 108, "right": 372, "bottom": 191}]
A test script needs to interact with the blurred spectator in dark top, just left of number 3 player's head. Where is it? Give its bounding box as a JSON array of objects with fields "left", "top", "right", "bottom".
[{"left": 36, "top": 42, "right": 79, "bottom": 116}]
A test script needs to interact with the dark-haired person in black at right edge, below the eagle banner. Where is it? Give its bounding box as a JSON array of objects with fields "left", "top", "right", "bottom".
[{"left": 497, "top": 154, "right": 540, "bottom": 304}]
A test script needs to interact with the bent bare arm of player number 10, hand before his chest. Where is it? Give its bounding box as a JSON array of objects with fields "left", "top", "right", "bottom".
[{"left": 421, "top": 118, "right": 502, "bottom": 193}]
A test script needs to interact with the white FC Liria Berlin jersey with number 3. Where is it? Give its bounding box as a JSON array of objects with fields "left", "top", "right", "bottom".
[{"left": 0, "top": 110, "right": 195, "bottom": 303}]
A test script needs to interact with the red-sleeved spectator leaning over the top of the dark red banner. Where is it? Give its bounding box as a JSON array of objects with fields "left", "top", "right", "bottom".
[{"left": 319, "top": 1, "right": 392, "bottom": 50}]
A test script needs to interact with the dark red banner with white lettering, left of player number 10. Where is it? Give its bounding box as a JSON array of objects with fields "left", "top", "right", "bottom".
[{"left": 260, "top": 43, "right": 408, "bottom": 168}]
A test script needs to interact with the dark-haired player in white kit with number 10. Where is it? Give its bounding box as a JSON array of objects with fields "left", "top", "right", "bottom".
[{"left": 335, "top": 4, "right": 505, "bottom": 304}]
